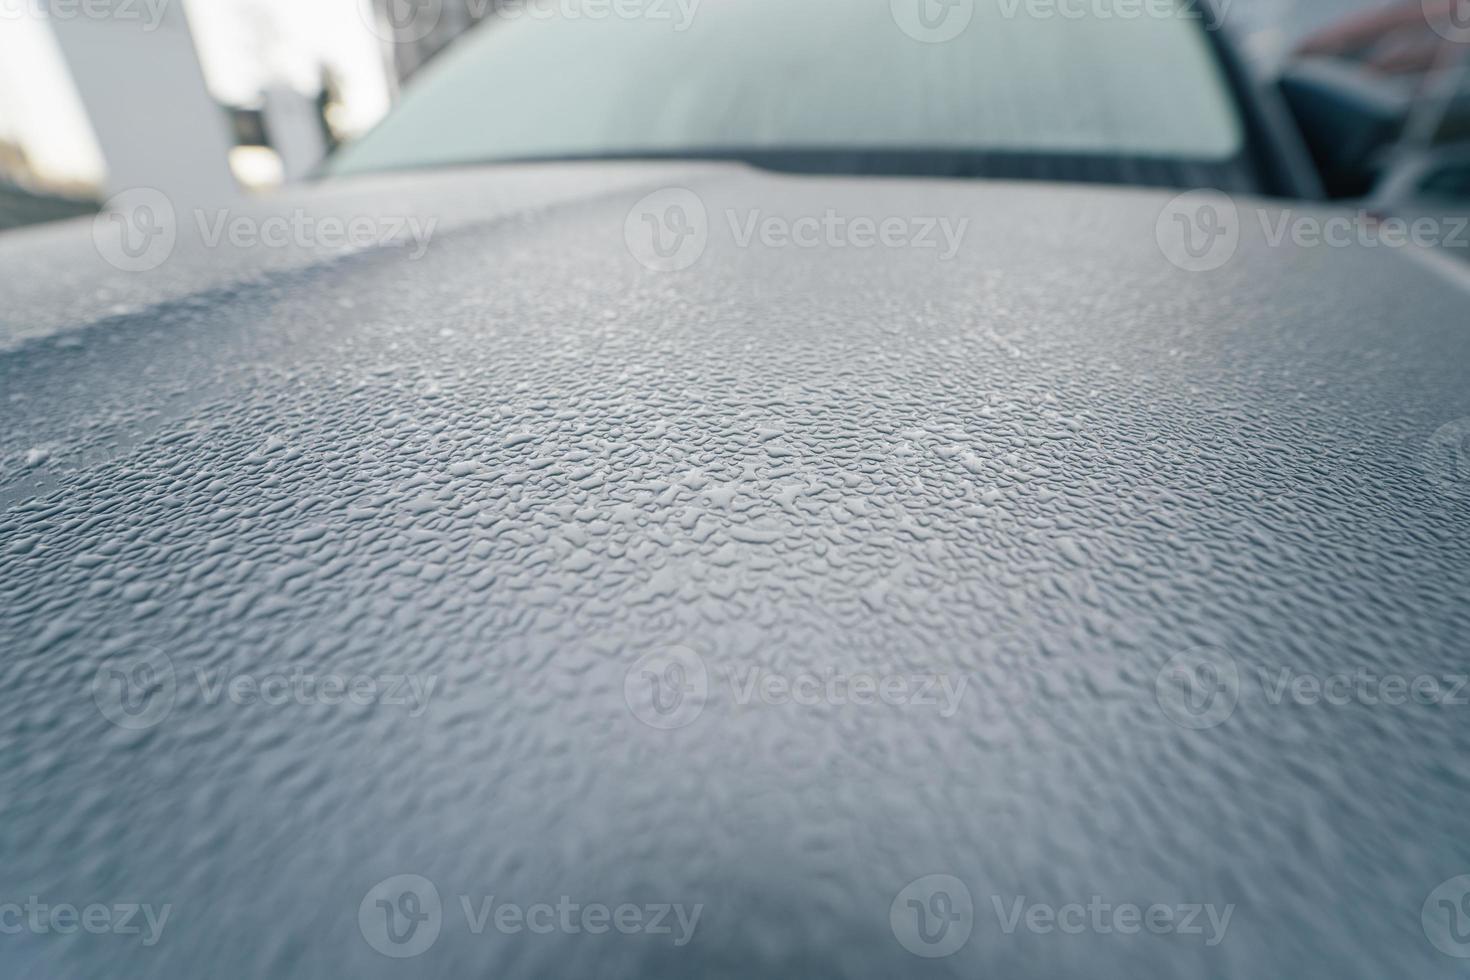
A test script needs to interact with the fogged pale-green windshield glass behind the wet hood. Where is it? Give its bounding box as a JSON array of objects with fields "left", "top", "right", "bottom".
[{"left": 329, "top": 0, "right": 1244, "bottom": 182}]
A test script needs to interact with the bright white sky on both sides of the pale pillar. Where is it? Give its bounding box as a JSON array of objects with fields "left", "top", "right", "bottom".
[{"left": 0, "top": 0, "right": 388, "bottom": 185}]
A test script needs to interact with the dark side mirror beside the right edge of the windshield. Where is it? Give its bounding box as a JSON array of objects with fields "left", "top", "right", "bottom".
[{"left": 1277, "top": 59, "right": 1411, "bottom": 197}]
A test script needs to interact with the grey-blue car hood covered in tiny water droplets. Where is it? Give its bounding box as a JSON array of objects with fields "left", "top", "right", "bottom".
[{"left": 0, "top": 163, "right": 1470, "bottom": 977}]
